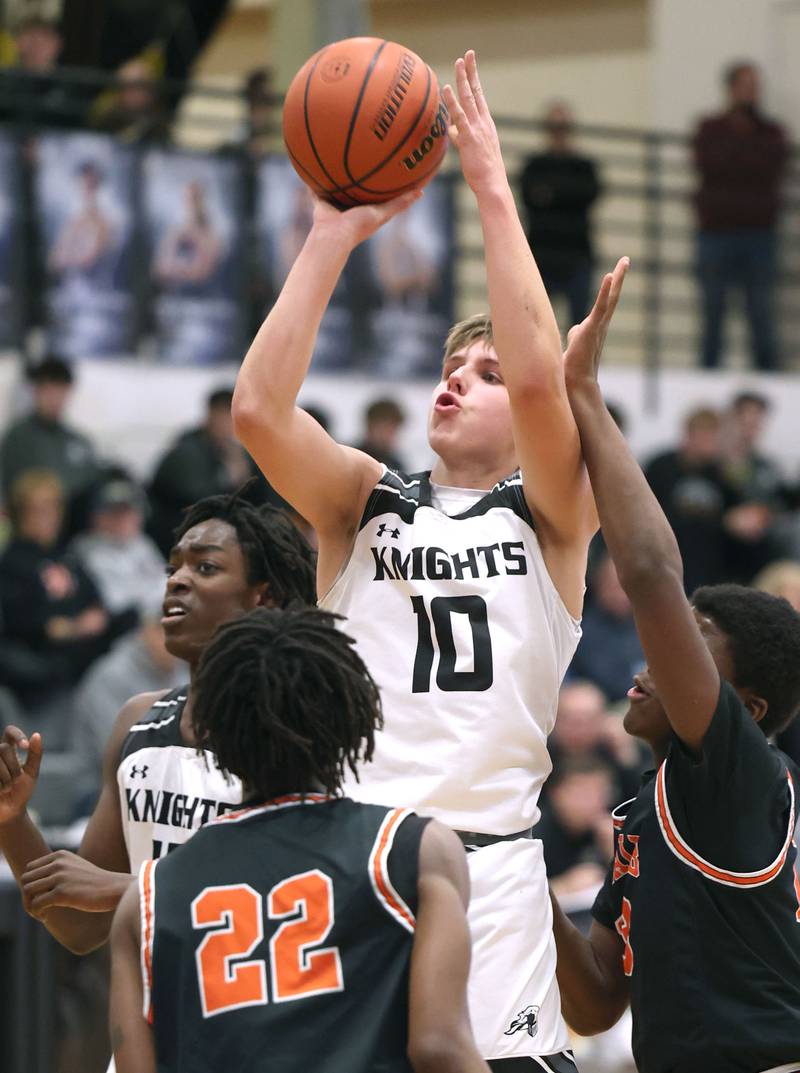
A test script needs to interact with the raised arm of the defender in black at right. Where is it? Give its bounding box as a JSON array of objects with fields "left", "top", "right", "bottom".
[{"left": 565, "top": 259, "right": 720, "bottom": 749}]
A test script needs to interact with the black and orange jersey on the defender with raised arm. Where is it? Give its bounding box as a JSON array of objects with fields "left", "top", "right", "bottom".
[{"left": 593, "top": 682, "right": 800, "bottom": 1073}]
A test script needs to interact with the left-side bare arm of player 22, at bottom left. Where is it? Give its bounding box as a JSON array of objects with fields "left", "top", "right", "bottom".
[{"left": 108, "top": 883, "right": 157, "bottom": 1073}]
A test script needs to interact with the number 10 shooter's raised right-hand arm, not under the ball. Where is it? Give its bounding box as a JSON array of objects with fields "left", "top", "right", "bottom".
[{"left": 444, "top": 52, "right": 596, "bottom": 614}]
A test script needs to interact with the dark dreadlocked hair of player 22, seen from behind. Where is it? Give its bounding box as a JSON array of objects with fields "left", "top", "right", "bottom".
[{"left": 192, "top": 607, "right": 383, "bottom": 798}]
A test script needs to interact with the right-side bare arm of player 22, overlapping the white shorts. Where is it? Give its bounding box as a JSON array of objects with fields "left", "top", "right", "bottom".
[{"left": 409, "top": 821, "right": 489, "bottom": 1073}]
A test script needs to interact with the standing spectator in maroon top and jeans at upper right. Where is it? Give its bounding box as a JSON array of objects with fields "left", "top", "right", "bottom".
[{"left": 694, "top": 61, "right": 788, "bottom": 369}]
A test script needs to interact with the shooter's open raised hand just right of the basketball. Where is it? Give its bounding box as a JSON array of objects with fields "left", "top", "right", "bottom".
[{"left": 442, "top": 49, "right": 507, "bottom": 194}]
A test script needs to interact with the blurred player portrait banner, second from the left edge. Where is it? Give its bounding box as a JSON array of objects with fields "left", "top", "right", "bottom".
[{"left": 34, "top": 133, "right": 138, "bottom": 358}]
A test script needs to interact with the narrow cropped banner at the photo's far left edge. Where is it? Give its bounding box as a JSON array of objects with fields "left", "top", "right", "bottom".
[{"left": 0, "top": 129, "right": 25, "bottom": 349}]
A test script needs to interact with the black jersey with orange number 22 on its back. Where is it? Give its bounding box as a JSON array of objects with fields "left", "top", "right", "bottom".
[{"left": 139, "top": 794, "right": 428, "bottom": 1073}]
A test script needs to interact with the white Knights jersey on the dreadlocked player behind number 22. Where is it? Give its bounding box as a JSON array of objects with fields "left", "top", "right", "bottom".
[{"left": 117, "top": 686, "right": 241, "bottom": 871}]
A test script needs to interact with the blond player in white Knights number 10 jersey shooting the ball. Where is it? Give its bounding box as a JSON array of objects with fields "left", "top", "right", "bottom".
[{"left": 234, "top": 53, "right": 617, "bottom": 1073}]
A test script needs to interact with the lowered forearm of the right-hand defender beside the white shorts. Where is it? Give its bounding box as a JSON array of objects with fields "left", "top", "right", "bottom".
[{"left": 550, "top": 894, "right": 622, "bottom": 1035}]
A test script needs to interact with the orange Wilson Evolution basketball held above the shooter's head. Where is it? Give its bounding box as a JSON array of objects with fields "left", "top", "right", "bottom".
[{"left": 283, "top": 38, "right": 447, "bottom": 208}]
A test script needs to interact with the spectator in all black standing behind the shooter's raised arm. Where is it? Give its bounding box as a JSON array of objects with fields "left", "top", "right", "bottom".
[{"left": 520, "top": 102, "right": 601, "bottom": 324}]
